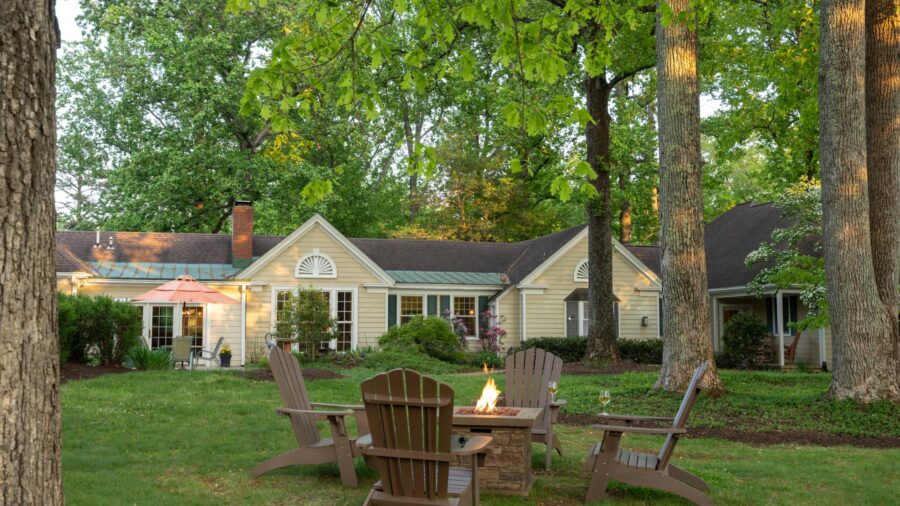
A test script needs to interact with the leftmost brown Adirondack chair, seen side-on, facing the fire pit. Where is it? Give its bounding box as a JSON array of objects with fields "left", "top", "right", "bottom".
[{"left": 253, "top": 347, "right": 368, "bottom": 487}]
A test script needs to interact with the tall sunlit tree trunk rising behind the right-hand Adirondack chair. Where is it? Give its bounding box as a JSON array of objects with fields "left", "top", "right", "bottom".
[{"left": 654, "top": 0, "right": 723, "bottom": 393}]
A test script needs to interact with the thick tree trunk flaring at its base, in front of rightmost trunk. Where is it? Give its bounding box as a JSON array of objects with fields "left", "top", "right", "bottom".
[{"left": 819, "top": 0, "right": 900, "bottom": 402}]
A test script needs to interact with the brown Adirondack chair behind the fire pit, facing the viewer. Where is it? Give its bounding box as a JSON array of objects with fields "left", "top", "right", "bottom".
[{"left": 504, "top": 348, "right": 566, "bottom": 471}]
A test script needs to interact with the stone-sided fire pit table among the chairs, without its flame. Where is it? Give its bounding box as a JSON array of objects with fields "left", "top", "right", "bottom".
[{"left": 451, "top": 408, "right": 541, "bottom": 495}]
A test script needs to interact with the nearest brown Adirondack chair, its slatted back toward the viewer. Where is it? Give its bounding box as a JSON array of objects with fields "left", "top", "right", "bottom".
[{"left": 362, "top": 369, "right": 493, "bottom": 506}]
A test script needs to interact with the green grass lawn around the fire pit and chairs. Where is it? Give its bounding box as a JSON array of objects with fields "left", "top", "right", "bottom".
[{"left": 62, "top": 369, "right": 900, "bottom": 506}]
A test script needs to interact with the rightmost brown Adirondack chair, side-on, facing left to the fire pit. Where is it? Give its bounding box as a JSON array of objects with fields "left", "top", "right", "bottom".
[{"left": 584, "top": 362, "right": 712, "bottom": 505}]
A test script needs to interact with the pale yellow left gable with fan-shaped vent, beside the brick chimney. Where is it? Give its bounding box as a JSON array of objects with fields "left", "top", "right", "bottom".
[{"left": 236, "top": 215, "right": 392, "bottom": 285}]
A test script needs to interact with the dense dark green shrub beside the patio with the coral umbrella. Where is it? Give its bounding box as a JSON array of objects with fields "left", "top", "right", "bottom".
[{"left": 57, "top": 293, "right": 143, "bottom": 365}]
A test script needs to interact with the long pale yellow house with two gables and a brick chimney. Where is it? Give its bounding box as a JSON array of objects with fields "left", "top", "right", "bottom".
[{"left": 56, "top": 202, "right": 661, "bottom": 364}]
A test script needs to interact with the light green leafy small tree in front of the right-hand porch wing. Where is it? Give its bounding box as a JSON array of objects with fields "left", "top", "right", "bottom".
[{"left": 746, "top": 177, "right": 828, "bottom": 330}]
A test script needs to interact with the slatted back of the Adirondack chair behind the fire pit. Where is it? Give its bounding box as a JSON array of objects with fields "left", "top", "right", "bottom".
[{"left": 504, "top": 348, "right": 562, "bottom": 429}]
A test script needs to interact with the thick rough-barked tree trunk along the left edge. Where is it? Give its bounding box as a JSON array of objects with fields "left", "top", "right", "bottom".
[{"left": 0, "top": 0, "right": 63, "bottom": 505}]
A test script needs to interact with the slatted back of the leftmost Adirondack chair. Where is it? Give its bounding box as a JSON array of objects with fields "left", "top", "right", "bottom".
[{"left": 269, "top": 347, "right": 319, "bottom": 446}]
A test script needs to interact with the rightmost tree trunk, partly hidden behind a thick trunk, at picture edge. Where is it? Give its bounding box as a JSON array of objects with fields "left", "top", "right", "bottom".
[{"left": 866, "top": 0, "right": 900, "bottom": 375}]
